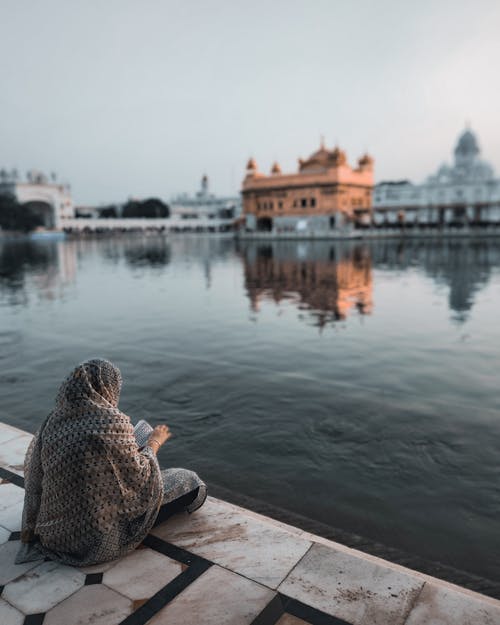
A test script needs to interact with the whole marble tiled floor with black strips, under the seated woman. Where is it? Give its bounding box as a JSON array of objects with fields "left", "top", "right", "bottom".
[{"left": 0, "top": 423, "right": 500, "bottom": 625}]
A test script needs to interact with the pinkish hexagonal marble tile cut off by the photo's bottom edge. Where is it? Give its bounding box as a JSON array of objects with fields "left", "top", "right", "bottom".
[{"left": 43, "top": 584, "right": 133, "bottom": 625}]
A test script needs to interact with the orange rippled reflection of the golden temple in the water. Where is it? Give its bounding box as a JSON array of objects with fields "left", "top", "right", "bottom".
[{"left": 240, "top": 242, "right": 373, "bottom": 327}]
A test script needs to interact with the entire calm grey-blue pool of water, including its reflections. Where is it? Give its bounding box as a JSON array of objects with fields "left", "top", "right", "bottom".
[{"left": 0, "top": 235, "right": 500, "bottom": 580}]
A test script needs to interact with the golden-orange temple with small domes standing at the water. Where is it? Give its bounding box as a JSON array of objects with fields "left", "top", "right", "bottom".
[{"left": 242, "top": 143, "right": 373, "bottom": 232}]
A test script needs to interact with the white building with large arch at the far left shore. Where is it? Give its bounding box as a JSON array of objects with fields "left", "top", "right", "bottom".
[{"left": 0, "top": 170, "right": 75, "bottom": 229}]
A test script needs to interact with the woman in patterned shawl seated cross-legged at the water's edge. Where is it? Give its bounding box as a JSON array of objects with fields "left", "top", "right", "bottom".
[{"left": 16, "top": 359, "right": 207, "bottom": 566}]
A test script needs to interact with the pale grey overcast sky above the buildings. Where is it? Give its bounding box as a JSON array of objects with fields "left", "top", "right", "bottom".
[{"left": 0, "top": 0, "right": 500, "bottom": 204}]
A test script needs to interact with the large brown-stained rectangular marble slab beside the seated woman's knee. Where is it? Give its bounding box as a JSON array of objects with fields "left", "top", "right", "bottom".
[{"left": 152, "top": 498, "right": 311, "bottom": 588}]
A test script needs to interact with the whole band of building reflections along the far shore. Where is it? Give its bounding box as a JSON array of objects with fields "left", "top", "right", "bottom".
[{"left": 0, "top": 235, "right": 500, "bottom": 327}]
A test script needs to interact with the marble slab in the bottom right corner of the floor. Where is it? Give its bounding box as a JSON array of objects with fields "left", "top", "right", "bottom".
[{"left": 405, "top": 583, "right": 500, "bottom": 625}]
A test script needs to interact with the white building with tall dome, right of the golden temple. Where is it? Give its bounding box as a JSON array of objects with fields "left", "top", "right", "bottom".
[{"left": 373, "top": 129, "right": 500, "bottom": 227}]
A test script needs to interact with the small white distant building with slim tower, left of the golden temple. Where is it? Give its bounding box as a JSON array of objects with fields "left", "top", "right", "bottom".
[{"left": 170, "top": 175, "right": 241, "bottom": 220}]
